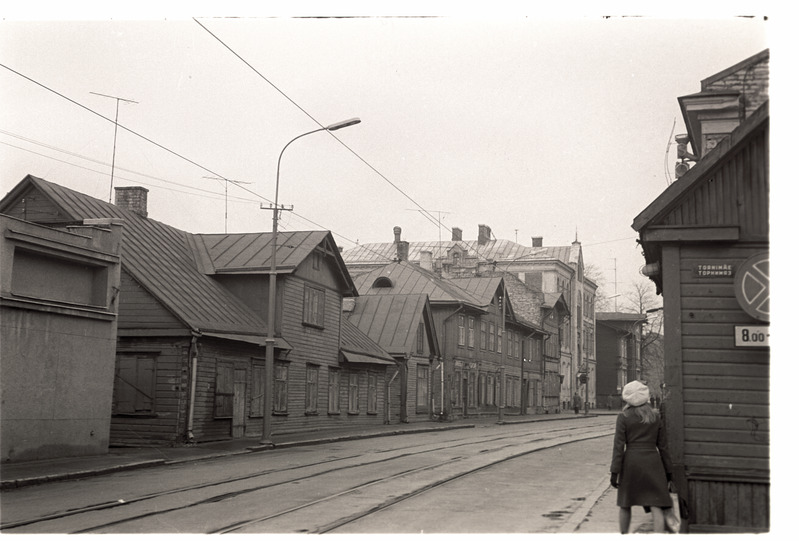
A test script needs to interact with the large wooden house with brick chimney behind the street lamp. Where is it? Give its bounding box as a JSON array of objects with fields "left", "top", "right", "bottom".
[{"left": 0, "top": 176, "right": 391, "bottom": 445}]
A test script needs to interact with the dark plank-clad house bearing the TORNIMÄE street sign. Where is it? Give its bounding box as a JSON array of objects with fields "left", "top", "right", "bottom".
[{"left": 632, "top": 51, "right": 770, "bottom": 532}]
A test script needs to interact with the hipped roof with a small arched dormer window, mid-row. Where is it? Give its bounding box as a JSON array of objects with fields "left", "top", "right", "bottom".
[{"left": 355, "top": 261, "right": 488, "bottom": 309}]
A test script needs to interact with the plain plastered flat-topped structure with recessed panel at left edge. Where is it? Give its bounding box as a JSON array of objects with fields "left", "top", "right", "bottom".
[{"left": 0, "top": 214, "right": 122, "bottom": 462}]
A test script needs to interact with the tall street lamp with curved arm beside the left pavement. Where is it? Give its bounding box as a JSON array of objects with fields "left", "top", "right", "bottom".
[{"left": 261, "top": 118, "right": 361, "bottom": 447}]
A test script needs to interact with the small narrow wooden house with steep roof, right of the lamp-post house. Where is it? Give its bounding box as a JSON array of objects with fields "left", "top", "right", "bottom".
[{"left": 345, "top": 294, "right": 443, "bottom": 424}]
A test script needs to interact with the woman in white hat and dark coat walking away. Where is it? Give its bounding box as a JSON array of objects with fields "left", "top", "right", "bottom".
[{"left": 610, "top": 381, "right": 671, "bottom": 534}]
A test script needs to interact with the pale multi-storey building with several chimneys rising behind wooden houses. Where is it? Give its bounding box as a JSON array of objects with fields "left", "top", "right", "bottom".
[{"left": 342, "top": 225, "right": 597, "bottom": 410}]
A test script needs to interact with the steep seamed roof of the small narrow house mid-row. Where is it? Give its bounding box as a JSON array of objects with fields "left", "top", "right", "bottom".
[{"left": 348, "top": 294, "right": 439, "bottom": 357}]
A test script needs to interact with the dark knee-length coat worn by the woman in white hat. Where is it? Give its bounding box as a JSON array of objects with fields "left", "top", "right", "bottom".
[{"left": 610, "top": 408, "right": 671, "bottom": 507}]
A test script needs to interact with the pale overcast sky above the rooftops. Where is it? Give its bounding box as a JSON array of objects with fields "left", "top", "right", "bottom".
[{"left": 0, "top": 9, "right": 771, "bottom": 304}]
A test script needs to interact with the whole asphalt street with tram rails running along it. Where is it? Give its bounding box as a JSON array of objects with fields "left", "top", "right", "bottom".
[{"left": 2, "top": 416, "right": 614, "bottom": 534}]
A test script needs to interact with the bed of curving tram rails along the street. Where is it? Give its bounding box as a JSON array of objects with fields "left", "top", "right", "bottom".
[{"left": 0, "top": 421, "right": 613, "bottom": 534}]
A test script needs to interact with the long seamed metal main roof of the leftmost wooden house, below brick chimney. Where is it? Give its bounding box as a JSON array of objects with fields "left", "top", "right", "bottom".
[{"left": 0, "top": 175, "right": 253, "bottom": 335}]
